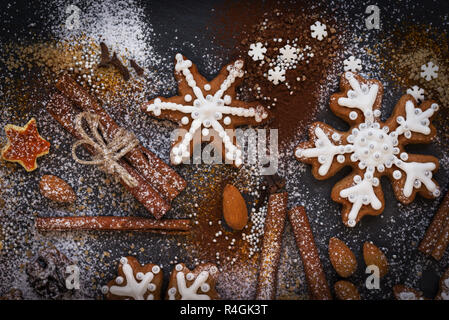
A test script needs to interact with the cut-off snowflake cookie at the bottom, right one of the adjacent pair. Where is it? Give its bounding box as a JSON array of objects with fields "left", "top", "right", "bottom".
[{"left": 166, "top": 263, "right": 220, "bottom": 300}]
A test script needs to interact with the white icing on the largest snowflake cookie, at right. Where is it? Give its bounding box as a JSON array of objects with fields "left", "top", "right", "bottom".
[{"left": 295, "top": 72, "right": 441, "bottom": 226}]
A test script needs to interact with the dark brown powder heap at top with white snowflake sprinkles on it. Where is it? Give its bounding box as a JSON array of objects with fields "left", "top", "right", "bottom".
[{"left": 212, "top": 1, "right": 341, "bottom": 144}]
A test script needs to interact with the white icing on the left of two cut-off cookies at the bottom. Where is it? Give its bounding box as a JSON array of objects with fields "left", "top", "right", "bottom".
[{"left": 109, "top": 258, "right": 154, "bottom": 300}]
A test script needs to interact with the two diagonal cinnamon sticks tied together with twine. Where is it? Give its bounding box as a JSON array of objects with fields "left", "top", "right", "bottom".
[{"left": 46, "top": 75, "right": 186, "bottom": 219}]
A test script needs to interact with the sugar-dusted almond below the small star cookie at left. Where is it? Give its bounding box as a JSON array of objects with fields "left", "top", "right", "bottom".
[{"left": 39, "top": 175, "right": 76, "bottom": 203}]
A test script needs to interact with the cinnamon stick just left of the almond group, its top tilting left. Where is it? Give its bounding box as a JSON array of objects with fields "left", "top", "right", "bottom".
[{"left": 288, "top": 207, "right": 332, "bottom": 300}]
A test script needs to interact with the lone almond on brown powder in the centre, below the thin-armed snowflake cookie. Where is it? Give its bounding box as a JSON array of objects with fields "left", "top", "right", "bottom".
[{"left": 223, "top": 184, "right": 248, "bottom": 230}]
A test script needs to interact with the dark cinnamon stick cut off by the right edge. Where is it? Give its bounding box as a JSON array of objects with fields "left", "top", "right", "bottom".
[{"left": 418, "top": 192, "right": 449, "bottom": 256}]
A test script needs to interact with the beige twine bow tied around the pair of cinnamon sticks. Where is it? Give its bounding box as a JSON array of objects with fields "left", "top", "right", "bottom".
[{"left": 72, "top": 112, "right": 139, "bottom": 187}]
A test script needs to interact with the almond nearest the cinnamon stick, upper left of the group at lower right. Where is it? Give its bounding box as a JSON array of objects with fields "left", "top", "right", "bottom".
[{"left": 329, "top": 238, "right": 357, "bottom": 278}]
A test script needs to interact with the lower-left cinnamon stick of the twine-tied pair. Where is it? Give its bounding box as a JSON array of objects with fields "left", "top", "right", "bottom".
[{"left": 47, "top": 94, "right": 170, "bottom": 219}]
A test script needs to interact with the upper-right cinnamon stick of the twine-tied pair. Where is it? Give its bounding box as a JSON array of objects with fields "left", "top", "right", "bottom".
[{"left": 56, "top": 75, "right": 186, "bottom": 202}]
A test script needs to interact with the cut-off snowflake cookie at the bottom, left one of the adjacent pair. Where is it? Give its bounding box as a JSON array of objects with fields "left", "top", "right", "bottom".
[{"left": 101, "top": 257, "right": 163, "bottom": 300}]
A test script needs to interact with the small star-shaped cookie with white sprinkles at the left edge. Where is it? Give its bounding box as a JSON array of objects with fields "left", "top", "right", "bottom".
[{"left": 2, "top": 118, "right": 50, "bottom": 171}]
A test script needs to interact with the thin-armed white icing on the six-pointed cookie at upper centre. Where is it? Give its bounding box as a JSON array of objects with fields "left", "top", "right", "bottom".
[{"left": 147, "top": 53, "right": 268, "bottom": 165}]
